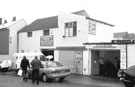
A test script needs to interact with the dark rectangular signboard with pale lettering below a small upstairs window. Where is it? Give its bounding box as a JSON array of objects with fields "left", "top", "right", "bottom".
[{"left": 40, "top": 35, "right": 53, "bottom": 46}]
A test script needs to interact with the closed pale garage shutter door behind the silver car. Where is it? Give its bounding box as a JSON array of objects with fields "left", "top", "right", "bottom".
[{"left": 59, "top": 50, "right": 83, "bottom": 74}]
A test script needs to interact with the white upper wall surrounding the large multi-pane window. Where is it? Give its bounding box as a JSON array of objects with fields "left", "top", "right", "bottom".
[{"left": 54, "top": 13, "right": 87, "bottom": 46}]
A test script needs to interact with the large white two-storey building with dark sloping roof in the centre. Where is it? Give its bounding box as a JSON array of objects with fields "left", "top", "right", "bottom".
[{"left": 18, "top": 10, "right": 114, "bottom": 75}]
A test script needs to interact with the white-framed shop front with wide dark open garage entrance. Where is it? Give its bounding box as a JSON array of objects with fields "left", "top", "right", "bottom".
[{"left": 85, "top": 42, "right": 127, "bottom": 77}]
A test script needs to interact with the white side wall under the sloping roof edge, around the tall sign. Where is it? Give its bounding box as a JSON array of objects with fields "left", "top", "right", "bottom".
[{"left": 88, "top": 22, "right": 114, "bottom": 42}]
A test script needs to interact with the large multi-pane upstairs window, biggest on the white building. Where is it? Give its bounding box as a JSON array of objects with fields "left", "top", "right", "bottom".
[{"left": 65, "top": 22, "right": 77, "bottom": 37}]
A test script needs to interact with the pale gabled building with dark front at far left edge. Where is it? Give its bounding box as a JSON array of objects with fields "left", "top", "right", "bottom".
[{"left": 0, "top": 19, "right": 26, "bottom": 60}]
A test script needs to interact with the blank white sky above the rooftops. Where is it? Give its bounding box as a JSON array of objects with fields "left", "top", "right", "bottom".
[{"left": 0, "top": 0, "right": 135, "bottom": 33}]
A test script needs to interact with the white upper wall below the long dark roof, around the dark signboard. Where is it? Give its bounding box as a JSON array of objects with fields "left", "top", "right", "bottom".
[{"left": 19, "top": 28, "right": 58, "bottom": 52}]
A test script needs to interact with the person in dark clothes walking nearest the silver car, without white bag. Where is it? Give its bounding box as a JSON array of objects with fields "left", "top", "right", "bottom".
[{"left": 31, "top": 56, "right": 41, "bottom": 85}]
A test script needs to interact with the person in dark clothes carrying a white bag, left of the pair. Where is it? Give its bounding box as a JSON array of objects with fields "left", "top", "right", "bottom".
[{"left": 20, "top": 56, "right": 30, "bottom": 82}]
